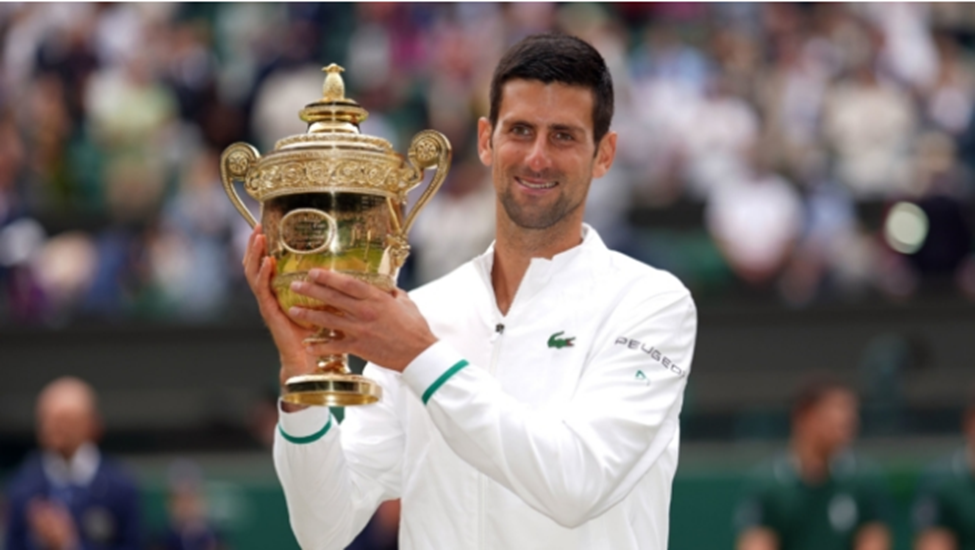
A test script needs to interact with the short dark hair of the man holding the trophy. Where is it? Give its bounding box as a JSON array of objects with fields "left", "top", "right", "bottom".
[{"left": 488, "top": 33, "right": 613, "bottom": 144}]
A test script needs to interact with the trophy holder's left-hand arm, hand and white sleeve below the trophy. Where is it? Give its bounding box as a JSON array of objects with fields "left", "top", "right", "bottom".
[{"left": 244, "top": 226, "right": 403, "bottom": 550}]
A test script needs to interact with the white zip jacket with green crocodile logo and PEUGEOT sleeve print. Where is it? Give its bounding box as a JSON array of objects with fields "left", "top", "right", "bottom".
[{"left": 274, "top": 227, "right": 697, "bottom": 550}]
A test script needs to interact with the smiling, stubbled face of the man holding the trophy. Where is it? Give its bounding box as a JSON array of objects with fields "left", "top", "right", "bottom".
[{"left": 478, "top": 79, "right": 616, "bottom": 229}]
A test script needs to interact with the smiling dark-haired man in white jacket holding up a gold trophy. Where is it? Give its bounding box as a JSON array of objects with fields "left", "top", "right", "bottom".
[{"left": 244, "top": 35, "right": 697, "bottom": 550}]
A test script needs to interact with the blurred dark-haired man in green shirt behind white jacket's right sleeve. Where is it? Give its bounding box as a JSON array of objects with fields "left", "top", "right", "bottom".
[{"left": 736, "top": 380, "right": 890, "bottom": 550}]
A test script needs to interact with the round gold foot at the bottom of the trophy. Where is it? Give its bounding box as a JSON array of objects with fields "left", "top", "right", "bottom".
[{"left": 281, "top": 373, "right": 383, "bottom": 407}]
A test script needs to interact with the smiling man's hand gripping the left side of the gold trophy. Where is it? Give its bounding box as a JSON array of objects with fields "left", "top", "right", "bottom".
[{"left": 244, "top": 225, "right": 315, "bottom": 385}]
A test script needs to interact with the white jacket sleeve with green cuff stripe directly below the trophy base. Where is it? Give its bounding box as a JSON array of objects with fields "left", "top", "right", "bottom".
[{"left": 274, "top": 366, "right": 404, "bottom": 550}]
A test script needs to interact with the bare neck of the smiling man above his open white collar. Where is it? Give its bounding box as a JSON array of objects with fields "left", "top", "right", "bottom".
[{"left": 491, "top": 216, "right": 582, "bottom": 315}]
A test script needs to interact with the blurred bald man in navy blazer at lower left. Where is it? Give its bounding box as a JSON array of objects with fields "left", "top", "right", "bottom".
[{"left": 6, "top": 377, "right": 142, "bottom": 550}]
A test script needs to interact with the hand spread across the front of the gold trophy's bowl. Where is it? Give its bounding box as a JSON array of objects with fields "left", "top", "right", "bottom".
[{"left": 288, "top": 269, "right": 437, "bottom": 372}]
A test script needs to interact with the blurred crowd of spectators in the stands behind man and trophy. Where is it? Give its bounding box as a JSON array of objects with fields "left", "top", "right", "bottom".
[{"left": 0, "top": 3, "right": 975, "bottom": 325}]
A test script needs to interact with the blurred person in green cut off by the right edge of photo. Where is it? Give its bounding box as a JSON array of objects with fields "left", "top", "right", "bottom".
[{"left": 914, "top": 398, "right": 975, "bottom": 550}]
